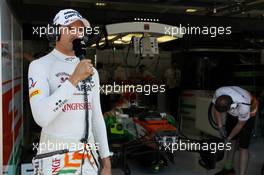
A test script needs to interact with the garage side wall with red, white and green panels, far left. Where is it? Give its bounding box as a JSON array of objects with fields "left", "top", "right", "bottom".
[{"left": 0, "top": 0, "right": 23, "bottom": 175}]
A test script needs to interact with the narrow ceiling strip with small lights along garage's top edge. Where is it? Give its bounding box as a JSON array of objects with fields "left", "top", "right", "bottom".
[{"left": 10, "top": 0, "right": 264, "bottom": 18}]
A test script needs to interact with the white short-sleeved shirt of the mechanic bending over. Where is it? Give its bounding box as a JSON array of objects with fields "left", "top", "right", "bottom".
[{"left": 212, "top": 86, "right": 251, "bottom": 121}]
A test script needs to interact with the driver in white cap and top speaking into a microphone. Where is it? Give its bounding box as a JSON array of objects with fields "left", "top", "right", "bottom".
[{"left": 28, "top": 9, "right": 111, "bottom": 175}]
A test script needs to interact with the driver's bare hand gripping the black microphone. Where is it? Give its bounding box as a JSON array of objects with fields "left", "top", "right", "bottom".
[{"left": 69, "top": 59, "right": 94, "bottom": 86}]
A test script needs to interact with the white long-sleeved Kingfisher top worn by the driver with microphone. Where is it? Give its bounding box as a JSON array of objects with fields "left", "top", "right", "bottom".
[{"left": 28, "top": 49, "right": 110, "bottom": 158}]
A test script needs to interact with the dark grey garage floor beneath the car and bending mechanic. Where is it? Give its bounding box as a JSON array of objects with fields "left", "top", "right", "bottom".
[{"left": 112, "top": 137, "right": 264, "bottom": 175}]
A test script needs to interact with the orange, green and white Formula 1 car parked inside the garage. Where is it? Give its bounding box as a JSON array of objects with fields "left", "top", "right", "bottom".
[{"left": 104, "top": 108, "right": 223, "bottom": 175}]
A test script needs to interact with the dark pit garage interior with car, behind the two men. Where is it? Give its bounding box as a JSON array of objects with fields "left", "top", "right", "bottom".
[{"left": 0, "top": 0, "right": 264, "bottom": 175}]
